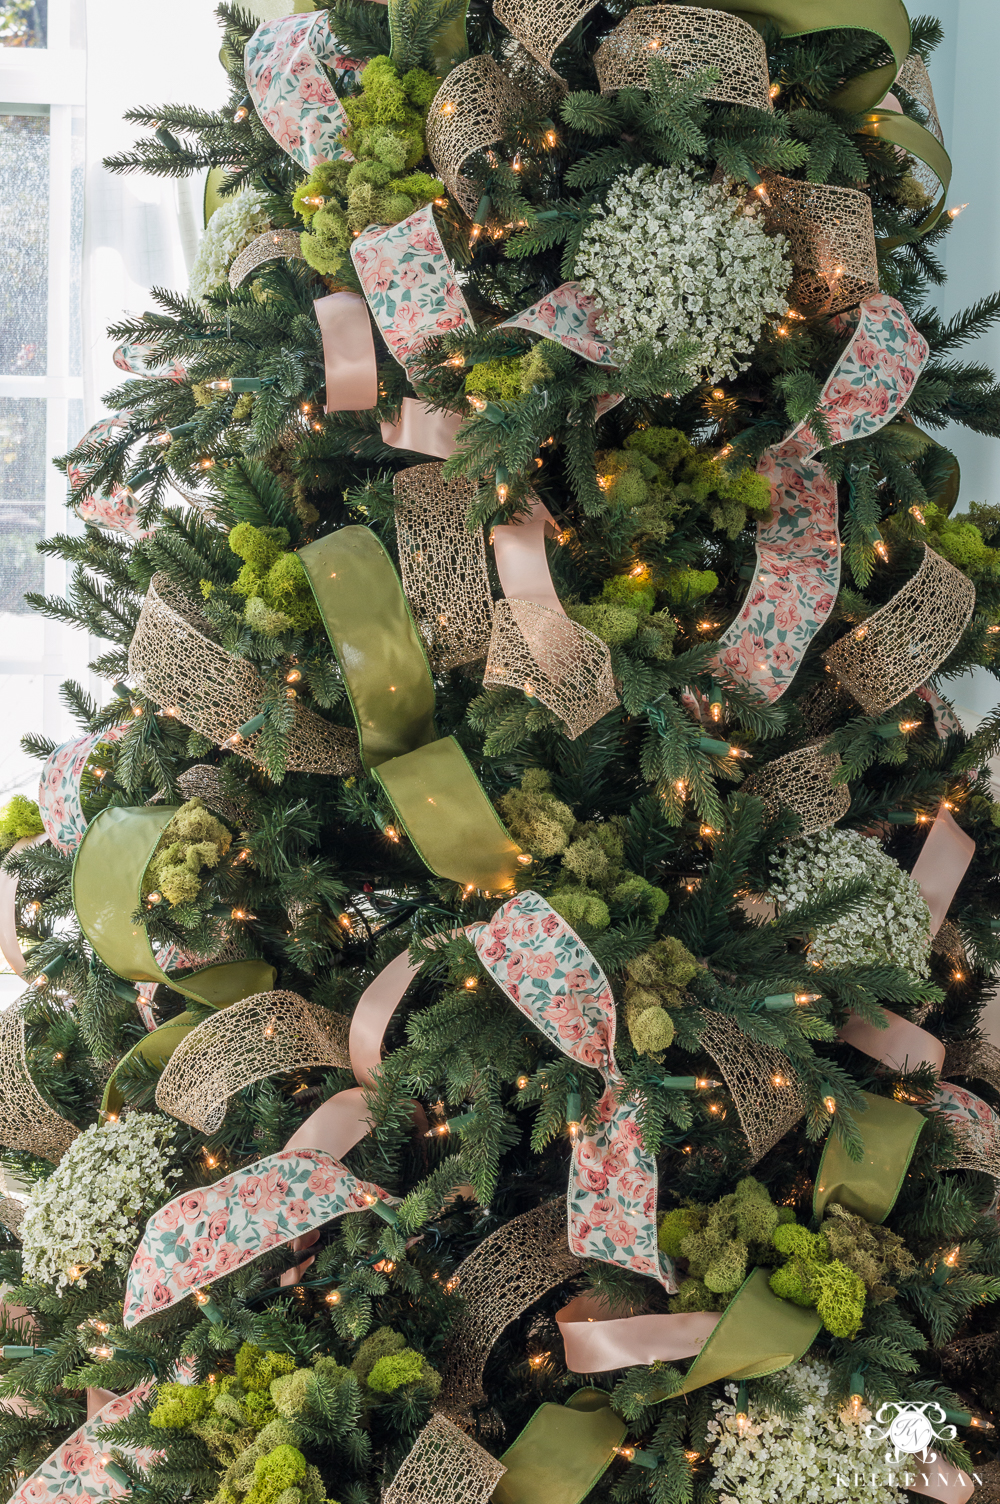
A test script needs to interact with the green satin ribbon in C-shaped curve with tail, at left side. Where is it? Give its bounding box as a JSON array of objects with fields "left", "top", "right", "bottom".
[{"left": 72, "top": 805, "right": 274, "bottom": 1008}]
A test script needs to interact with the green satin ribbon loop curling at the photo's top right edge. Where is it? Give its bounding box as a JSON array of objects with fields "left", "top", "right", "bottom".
[{"left": 689, "top": 0, "right": 910, "bottom": 114}]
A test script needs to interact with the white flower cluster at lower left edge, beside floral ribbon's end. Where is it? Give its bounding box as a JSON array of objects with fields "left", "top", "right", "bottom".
[{"left": 21, "top": 1113, "right": 177, "bottom": 1290}]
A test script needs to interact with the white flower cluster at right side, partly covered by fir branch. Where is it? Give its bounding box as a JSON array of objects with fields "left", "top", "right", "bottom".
[{"left": 771, "top": 830, "right": 931, "bottom": 976}]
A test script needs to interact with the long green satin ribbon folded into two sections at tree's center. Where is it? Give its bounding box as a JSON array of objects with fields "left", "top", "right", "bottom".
[{"left": 299, "top": 526, "right": 519, "bottom": 892}]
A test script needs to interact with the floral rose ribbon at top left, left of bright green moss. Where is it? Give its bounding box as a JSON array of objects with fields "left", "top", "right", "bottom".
[{"left": 244, "top": 11, "right": 364, "bottom": 173}]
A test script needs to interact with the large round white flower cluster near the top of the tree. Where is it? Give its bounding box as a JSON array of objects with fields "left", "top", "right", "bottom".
[{"left": 576, "top": 167, "right": 792, "bottom": 381}]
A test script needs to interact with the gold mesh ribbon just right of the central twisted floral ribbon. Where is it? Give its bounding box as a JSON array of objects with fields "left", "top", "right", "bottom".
[{"left": 701, "top": 1014, "right": 806, "bottom": 1164}]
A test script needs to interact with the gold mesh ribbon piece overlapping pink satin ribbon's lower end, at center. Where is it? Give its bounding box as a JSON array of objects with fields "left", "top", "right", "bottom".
[{"left": 483, "top": 600, "right": 618, "bottom": 740}]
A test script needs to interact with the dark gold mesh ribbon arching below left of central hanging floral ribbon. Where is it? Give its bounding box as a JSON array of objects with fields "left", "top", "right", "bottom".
[{"left": 441, "top": 1199, "right": 582, "bottom": 1424}]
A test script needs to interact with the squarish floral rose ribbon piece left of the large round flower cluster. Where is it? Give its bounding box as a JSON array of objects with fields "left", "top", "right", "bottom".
[{"left": 350, "top": 205, "right": 474, "bottom": 365}]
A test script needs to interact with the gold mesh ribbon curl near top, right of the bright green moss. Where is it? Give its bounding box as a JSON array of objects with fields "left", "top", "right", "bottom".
[{"left": 427, "top": 53, "right": 525, "bottom": 217}]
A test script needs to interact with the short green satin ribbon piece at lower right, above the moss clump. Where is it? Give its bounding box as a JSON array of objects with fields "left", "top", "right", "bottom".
[{"left": 812, "top": 1092, "right": 926, "bottom": 1223}]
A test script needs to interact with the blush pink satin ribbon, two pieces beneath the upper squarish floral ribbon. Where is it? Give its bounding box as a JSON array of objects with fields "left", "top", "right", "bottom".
[{"left": 313, "top": 292, "right": 462, "bottom": 460}]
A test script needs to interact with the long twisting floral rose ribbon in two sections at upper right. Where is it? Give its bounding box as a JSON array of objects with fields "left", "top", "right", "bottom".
[{"left": 717, "top": 293, "right": 928, "bottom": 701}]
